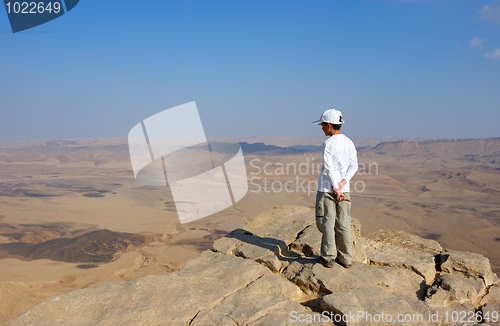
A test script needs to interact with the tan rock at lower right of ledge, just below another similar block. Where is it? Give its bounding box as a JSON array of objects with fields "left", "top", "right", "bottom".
[{"left": 425, "top": 274, "right": 486, "bottom": 307}]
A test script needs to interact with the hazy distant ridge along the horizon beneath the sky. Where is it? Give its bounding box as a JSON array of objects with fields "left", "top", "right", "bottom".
[{"left": 0, "top": 137, "right": 500, "bottom": 162}]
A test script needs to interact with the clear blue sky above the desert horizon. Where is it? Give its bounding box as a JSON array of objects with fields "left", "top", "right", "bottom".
[{"left": 0, "top": 0, "right": 500, "bottom": 140}]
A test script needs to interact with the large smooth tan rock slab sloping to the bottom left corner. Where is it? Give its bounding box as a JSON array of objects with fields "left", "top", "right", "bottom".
[{"left": 11, "top": 251, "right": 310, "bottom": 325}]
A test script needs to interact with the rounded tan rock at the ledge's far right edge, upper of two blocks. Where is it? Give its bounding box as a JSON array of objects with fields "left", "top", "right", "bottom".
[{"left": 439, "top": 249, "right": 496, "bottom": 286}]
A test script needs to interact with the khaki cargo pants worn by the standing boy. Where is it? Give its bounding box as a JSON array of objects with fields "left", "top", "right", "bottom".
[{"left": 316, "top": 191, "right": 352, "bottom": 265}]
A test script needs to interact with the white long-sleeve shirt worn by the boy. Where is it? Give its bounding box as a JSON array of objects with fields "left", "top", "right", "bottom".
[{"left": 317, "top": 134, "right": 358, "bottom": 192}]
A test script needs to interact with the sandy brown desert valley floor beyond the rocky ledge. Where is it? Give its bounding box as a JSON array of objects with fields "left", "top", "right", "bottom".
[{"left": 0, "top": 139, "right": 500, "bottom": 324}]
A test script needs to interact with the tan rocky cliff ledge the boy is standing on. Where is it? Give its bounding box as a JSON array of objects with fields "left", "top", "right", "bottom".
[{"left": 10, "top": 206, "right": 500, "bottom": 326}]
